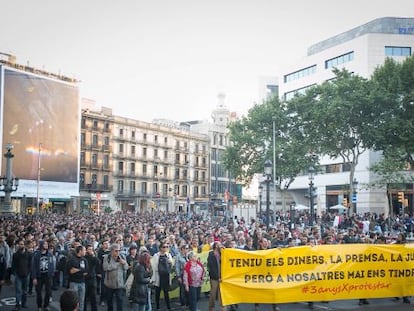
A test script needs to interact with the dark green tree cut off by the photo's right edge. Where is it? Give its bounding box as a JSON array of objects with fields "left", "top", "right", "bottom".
[{"left": 366, "top": 56, "right": 414, "bottom": 169}]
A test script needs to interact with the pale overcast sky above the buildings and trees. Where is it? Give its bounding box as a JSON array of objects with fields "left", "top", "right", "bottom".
[{"left": 0, "top": 0, "right": 414, "bottom": 122}]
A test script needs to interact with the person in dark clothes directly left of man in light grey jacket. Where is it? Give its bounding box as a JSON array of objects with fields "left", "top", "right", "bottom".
[{"left": 84, "top": 244, "right": 102, "bottom": 311}]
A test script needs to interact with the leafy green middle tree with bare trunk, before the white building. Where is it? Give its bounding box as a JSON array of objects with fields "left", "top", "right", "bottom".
[{"left": 288, "top": 69, "right": 375, "bottom": 210}]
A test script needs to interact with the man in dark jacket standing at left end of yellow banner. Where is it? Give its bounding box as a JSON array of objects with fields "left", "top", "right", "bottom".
[{"left": 207, "top": 241, "right": 226, "bottom": 311}]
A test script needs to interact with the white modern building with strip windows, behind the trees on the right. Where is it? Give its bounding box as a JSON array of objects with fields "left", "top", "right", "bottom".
[{"left": 279, "top": 17, "right": 414, "bottom": 217}]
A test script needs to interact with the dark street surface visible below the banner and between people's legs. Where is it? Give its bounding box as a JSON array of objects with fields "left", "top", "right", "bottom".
[{"left": 0, "top": 286, "right": 414, "bottom": 311}]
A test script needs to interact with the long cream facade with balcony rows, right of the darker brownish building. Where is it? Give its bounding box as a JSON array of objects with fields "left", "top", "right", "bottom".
[{"left": 112, "top": 116, "right": 209, "bottom": 212}]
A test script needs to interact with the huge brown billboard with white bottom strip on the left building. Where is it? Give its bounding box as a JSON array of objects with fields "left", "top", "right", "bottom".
[{"left": 0, "top": 66, "right": 80, "bottom": 198}]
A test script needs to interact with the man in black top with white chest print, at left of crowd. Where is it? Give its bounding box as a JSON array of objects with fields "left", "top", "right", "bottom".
[{"left": 31, "top": 240, "right": 55, "bottom": 311}]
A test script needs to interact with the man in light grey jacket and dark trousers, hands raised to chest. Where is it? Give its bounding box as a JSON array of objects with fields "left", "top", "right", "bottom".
[{"left": 103, "top": 243, "right": 128, "bottom": 311}]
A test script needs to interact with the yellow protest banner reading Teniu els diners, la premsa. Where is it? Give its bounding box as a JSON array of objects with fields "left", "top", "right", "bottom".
[{"left": 221, "top": 244, "right": 414, "bottom": 305}]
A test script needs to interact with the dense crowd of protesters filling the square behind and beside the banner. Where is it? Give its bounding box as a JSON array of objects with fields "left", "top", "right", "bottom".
[{"left": 0, "top": 208, "right": 413, "bottom": 311}]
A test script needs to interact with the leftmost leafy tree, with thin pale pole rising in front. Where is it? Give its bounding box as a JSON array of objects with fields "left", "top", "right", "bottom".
[{"left": 224, "top": 97, "right": 308, "bottom": 189}]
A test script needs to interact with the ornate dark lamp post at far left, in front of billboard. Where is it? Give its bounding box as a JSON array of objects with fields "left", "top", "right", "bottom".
[{"left": 0, "top": 144, "right": 19, "bottom": 214}]
